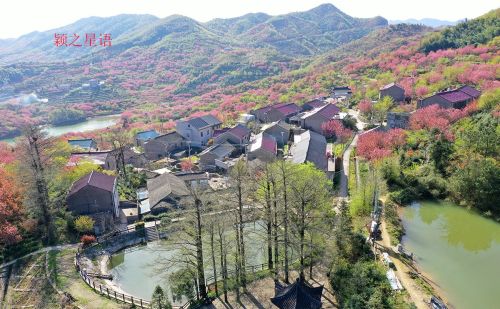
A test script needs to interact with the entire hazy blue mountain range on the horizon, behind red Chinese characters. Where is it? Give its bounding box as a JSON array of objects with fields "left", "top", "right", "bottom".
[{"left": 0, "top": 4, "right": 388, "bottom": 64}]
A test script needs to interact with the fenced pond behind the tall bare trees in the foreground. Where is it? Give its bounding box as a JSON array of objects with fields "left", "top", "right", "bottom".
[{"left": 108, "top": 222, "right": 266, "bottom": 304}]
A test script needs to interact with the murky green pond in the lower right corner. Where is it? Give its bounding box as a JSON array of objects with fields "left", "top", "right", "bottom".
[{"left": 402, "top": 202, "right": 500, "bottom": 309}]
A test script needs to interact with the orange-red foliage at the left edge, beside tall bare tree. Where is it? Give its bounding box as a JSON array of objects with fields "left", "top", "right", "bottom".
[{"left": 0, "top": 168, "right": 22, "bottom": 245}]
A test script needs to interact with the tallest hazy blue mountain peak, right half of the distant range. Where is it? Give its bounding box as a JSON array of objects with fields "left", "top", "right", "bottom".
[{"left": 206, "top": 4, "right": 388, "bottom": 55}]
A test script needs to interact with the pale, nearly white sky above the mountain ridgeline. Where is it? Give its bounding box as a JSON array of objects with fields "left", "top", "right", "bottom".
[{"left": 0, "top": 0, "right": 499, "bottom": 38}]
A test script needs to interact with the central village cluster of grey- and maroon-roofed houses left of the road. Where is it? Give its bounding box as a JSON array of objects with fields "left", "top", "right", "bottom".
[{"left": 63, "top": 92, "right": 350, "bottom": 233}]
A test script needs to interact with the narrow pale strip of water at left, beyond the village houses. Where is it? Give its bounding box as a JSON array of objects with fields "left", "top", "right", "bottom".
[{"left": 0, "top": 115, "right": 120, "bottom": 143}]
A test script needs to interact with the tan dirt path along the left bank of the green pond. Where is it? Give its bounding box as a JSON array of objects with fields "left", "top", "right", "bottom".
[{"left": 377, "top": 221, "right": 430, "bottom": 309}]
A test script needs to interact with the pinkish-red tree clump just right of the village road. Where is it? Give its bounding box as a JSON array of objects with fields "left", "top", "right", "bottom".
[{"left": 356, "top": 129, "right": 406, "bottom": 161}]
